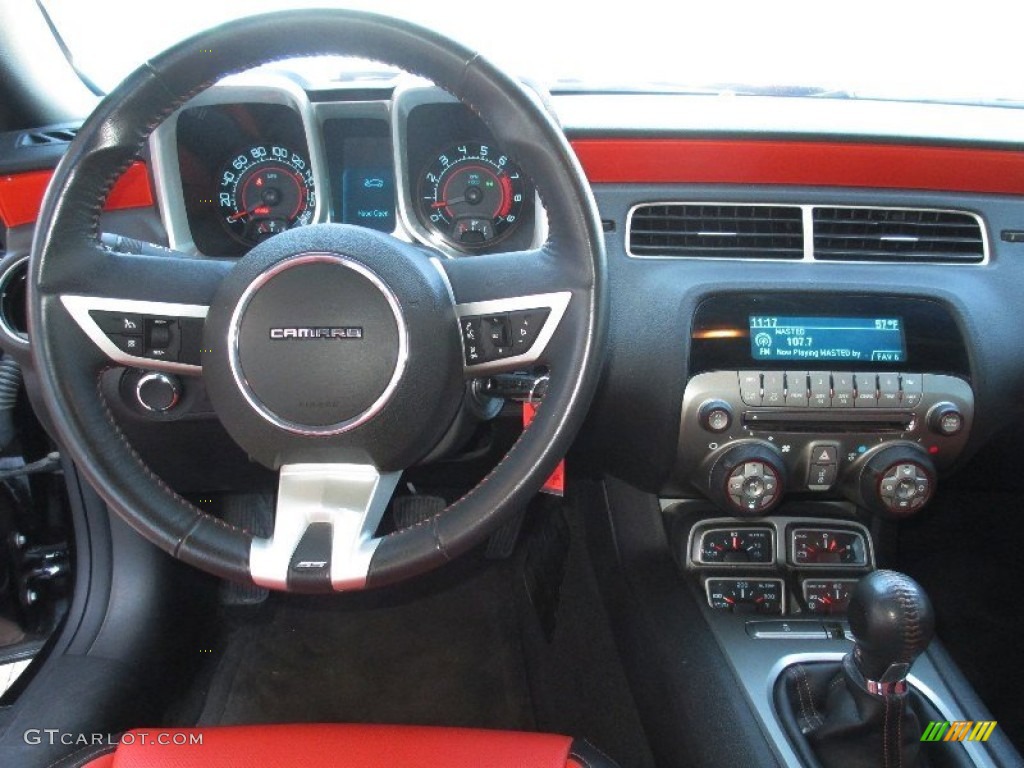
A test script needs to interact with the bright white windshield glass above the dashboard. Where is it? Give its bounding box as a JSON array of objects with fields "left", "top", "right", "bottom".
[{"left": 37, "top": 0, "right": 1024, "bottom": 106}]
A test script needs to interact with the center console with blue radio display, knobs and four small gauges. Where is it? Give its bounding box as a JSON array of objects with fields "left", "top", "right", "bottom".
[{"left": 662, "top": 293, "right": 993, "bottom": 766}]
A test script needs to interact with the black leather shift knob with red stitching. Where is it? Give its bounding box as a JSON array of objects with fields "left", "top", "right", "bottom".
[{"left": 848, "top": 570, "right": 935, "bottom": 684}]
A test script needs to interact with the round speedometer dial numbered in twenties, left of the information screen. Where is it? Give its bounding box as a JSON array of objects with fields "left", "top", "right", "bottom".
[{"left": 218, "top": 144, "right": 316, "bottom": 244}]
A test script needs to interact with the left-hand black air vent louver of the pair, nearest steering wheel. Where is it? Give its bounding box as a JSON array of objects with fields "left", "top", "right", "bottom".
[{"left": 629, "top": 203, "right": 804, "bottom": 259}]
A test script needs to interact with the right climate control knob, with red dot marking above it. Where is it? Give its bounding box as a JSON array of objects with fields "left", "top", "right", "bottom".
[{"left": 847, "top": 443, "right": 936, "bottom": 517}]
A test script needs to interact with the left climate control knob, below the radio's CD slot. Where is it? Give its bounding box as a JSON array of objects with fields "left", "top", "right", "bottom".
[{"left": 696, "top": 440, "right": 785, "bottom": 515}]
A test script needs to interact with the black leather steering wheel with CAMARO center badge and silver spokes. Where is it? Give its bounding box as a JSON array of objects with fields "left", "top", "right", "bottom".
[{"left": 29, "top": 10, "right": 605, "bottom": 591}]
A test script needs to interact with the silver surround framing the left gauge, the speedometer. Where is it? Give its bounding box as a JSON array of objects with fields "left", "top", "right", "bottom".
[{"left": 150, "top": 78, "right": 331, "bottom": 256}]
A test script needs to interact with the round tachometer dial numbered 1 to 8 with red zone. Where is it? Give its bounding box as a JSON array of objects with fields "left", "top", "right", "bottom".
[{"left": 418, "top": 141, "right": 528, "bottom": 250}]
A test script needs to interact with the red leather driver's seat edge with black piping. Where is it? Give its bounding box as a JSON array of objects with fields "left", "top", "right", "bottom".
[{"left": 76, "top": 725, "right": 614, "bottom": 768}]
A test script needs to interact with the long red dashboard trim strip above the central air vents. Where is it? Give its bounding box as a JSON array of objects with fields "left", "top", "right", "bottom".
[{"left": 572, "top": 138, "right": 1024, "bottom": 195}]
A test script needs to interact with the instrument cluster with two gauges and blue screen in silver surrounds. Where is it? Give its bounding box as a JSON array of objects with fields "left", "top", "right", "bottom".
[{"left": 151, "top": 78, "right": 543, "bottom": 257}]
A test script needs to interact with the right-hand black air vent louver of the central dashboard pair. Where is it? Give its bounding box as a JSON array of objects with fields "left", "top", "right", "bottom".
[{"left": 813, "top": 208, "right": 985, "bottom": 262}]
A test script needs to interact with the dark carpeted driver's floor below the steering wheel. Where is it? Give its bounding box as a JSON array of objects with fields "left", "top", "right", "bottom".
[{"left": 179, "top": 501, "right": 653, "bottom": 768}]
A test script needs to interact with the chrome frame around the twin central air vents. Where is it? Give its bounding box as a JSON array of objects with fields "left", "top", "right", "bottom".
[{"left": 623, "top": 202, "right": 991, "bottom": 267}]
